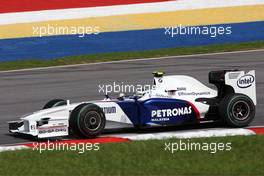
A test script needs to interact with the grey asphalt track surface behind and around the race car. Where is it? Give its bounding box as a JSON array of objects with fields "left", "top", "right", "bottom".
[{"left": 0, "top": 50, "right": 264, "bottom": 144}]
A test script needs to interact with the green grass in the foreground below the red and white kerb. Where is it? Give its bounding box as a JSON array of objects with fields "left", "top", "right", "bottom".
[{"left": 0, "top": 136, "right": 264, "bottom": 176}]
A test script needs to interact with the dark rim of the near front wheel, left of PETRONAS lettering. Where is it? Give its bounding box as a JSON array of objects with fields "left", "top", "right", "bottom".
[{"left": 84, "top": 111, "right": 102, "bottom": 131}]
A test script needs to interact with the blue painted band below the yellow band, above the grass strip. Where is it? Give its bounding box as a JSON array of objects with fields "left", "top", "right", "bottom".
[{"left": 0, "top": 21, "right": 264, "bottom": 61}]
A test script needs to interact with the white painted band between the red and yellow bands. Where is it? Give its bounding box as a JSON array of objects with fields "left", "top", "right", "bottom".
[{"left": 0, "top": 0, "right": 264, "bottom": 25}]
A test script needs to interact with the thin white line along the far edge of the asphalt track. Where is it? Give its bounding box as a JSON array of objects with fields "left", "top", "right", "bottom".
[{"left": 0, "top": 49, "right": 264, "bottom": 74}]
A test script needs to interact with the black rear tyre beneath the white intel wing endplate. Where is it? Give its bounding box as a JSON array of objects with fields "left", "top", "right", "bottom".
[{"left": 219, "top": 93, "right": 255, "bottom": 127}]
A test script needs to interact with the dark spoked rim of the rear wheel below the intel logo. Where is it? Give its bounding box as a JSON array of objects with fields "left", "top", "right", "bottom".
[{"left": 232, "top": 101, "right": 250, "bottom": 121}]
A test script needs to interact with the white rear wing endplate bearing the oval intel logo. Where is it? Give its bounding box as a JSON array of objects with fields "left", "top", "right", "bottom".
[{"left": 225, "top": 70, "right": 257, "bottom": 105}]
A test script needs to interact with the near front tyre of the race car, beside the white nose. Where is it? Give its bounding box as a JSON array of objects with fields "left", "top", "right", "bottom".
[{"left": 69, "top": 103, "right": 106, "bottom": 138}]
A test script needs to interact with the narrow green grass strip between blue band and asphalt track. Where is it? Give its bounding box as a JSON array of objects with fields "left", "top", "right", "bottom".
[{"left": 0, "top": 41, "right": 264, "bottom": 71}]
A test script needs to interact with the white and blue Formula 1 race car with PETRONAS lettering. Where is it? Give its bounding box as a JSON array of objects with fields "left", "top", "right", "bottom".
[{"left": 8, "top": 70, "right": 257, "bottom": 138}]
